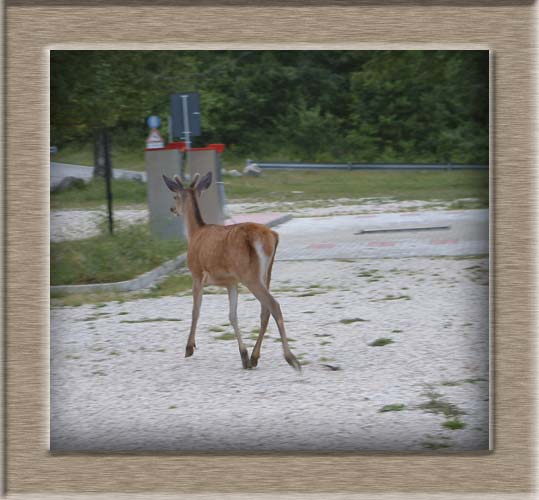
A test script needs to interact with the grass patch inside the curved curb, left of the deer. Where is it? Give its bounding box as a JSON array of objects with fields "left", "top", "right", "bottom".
[{"left": 50, "top": 224, "right": 186, "bottom": 285}]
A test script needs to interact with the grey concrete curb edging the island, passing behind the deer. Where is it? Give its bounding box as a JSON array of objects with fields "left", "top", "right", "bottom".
[{"left": 50, "top": 214, "right": 292, "bottom": 295}]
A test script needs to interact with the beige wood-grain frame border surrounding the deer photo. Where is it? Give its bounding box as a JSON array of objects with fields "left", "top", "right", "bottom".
[{"left": 4, "top": 0, "right": 537, "bottom": 499}]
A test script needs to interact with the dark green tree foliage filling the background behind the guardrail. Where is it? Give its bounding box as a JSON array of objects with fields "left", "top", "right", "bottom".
[{"left": 51, "top": 50, "right": 489, "bottom": 163}]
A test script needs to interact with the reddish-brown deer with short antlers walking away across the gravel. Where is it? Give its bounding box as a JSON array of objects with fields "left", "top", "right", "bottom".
[{"left": 163, "top": 172, "right": 301, "bottom": 372}]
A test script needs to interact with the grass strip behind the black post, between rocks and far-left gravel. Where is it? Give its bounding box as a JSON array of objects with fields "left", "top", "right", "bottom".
[{"left": 51, "top": 178, "right": 148, "bottom": 210}]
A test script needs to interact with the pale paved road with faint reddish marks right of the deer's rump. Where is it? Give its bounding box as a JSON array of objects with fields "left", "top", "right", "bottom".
[{"left": 277, "top": 209, "right": 489, "bottom": 260}]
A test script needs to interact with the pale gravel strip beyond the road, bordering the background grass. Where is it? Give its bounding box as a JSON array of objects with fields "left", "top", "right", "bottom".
[{"left": 50, "top": 198, "right": 476, "bottom": 241}]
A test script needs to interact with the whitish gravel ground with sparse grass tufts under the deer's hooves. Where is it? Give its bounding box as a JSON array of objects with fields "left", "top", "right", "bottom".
[{"left": 51, "top": 257, "right": 489, "bottom": 451}]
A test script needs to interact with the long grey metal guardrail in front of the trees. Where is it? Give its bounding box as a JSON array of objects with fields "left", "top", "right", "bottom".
[{"left": 249, "top": 161, "right": 488, "bottom": 174}]
